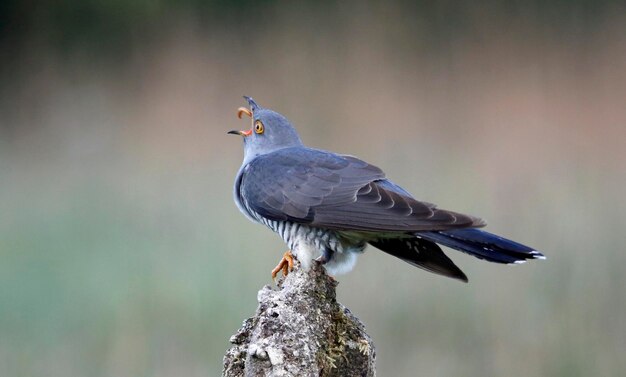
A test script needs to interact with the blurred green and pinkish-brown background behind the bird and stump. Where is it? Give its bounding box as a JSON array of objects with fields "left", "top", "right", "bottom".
[{"left": 0, "top": 0, "right": 626, "bottom": 377}]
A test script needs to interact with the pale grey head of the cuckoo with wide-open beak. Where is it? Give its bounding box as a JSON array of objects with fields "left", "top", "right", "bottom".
[{"left": 228, "top": 96, "right": 302, "bottom": 162}]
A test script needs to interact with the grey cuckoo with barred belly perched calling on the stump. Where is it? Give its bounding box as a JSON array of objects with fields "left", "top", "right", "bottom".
[{"left": 229, "top": 97, "right": 543, "bottom": 281}]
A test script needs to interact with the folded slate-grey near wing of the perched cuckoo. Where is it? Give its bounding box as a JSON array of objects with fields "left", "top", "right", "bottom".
[{"left": 239, "top": 148, "right": 484, "bottom": 232}]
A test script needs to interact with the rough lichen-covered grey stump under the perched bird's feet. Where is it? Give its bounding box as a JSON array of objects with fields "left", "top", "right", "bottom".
[{"left": 222, "top": 261, "right": 376, "bottom": 377}]
